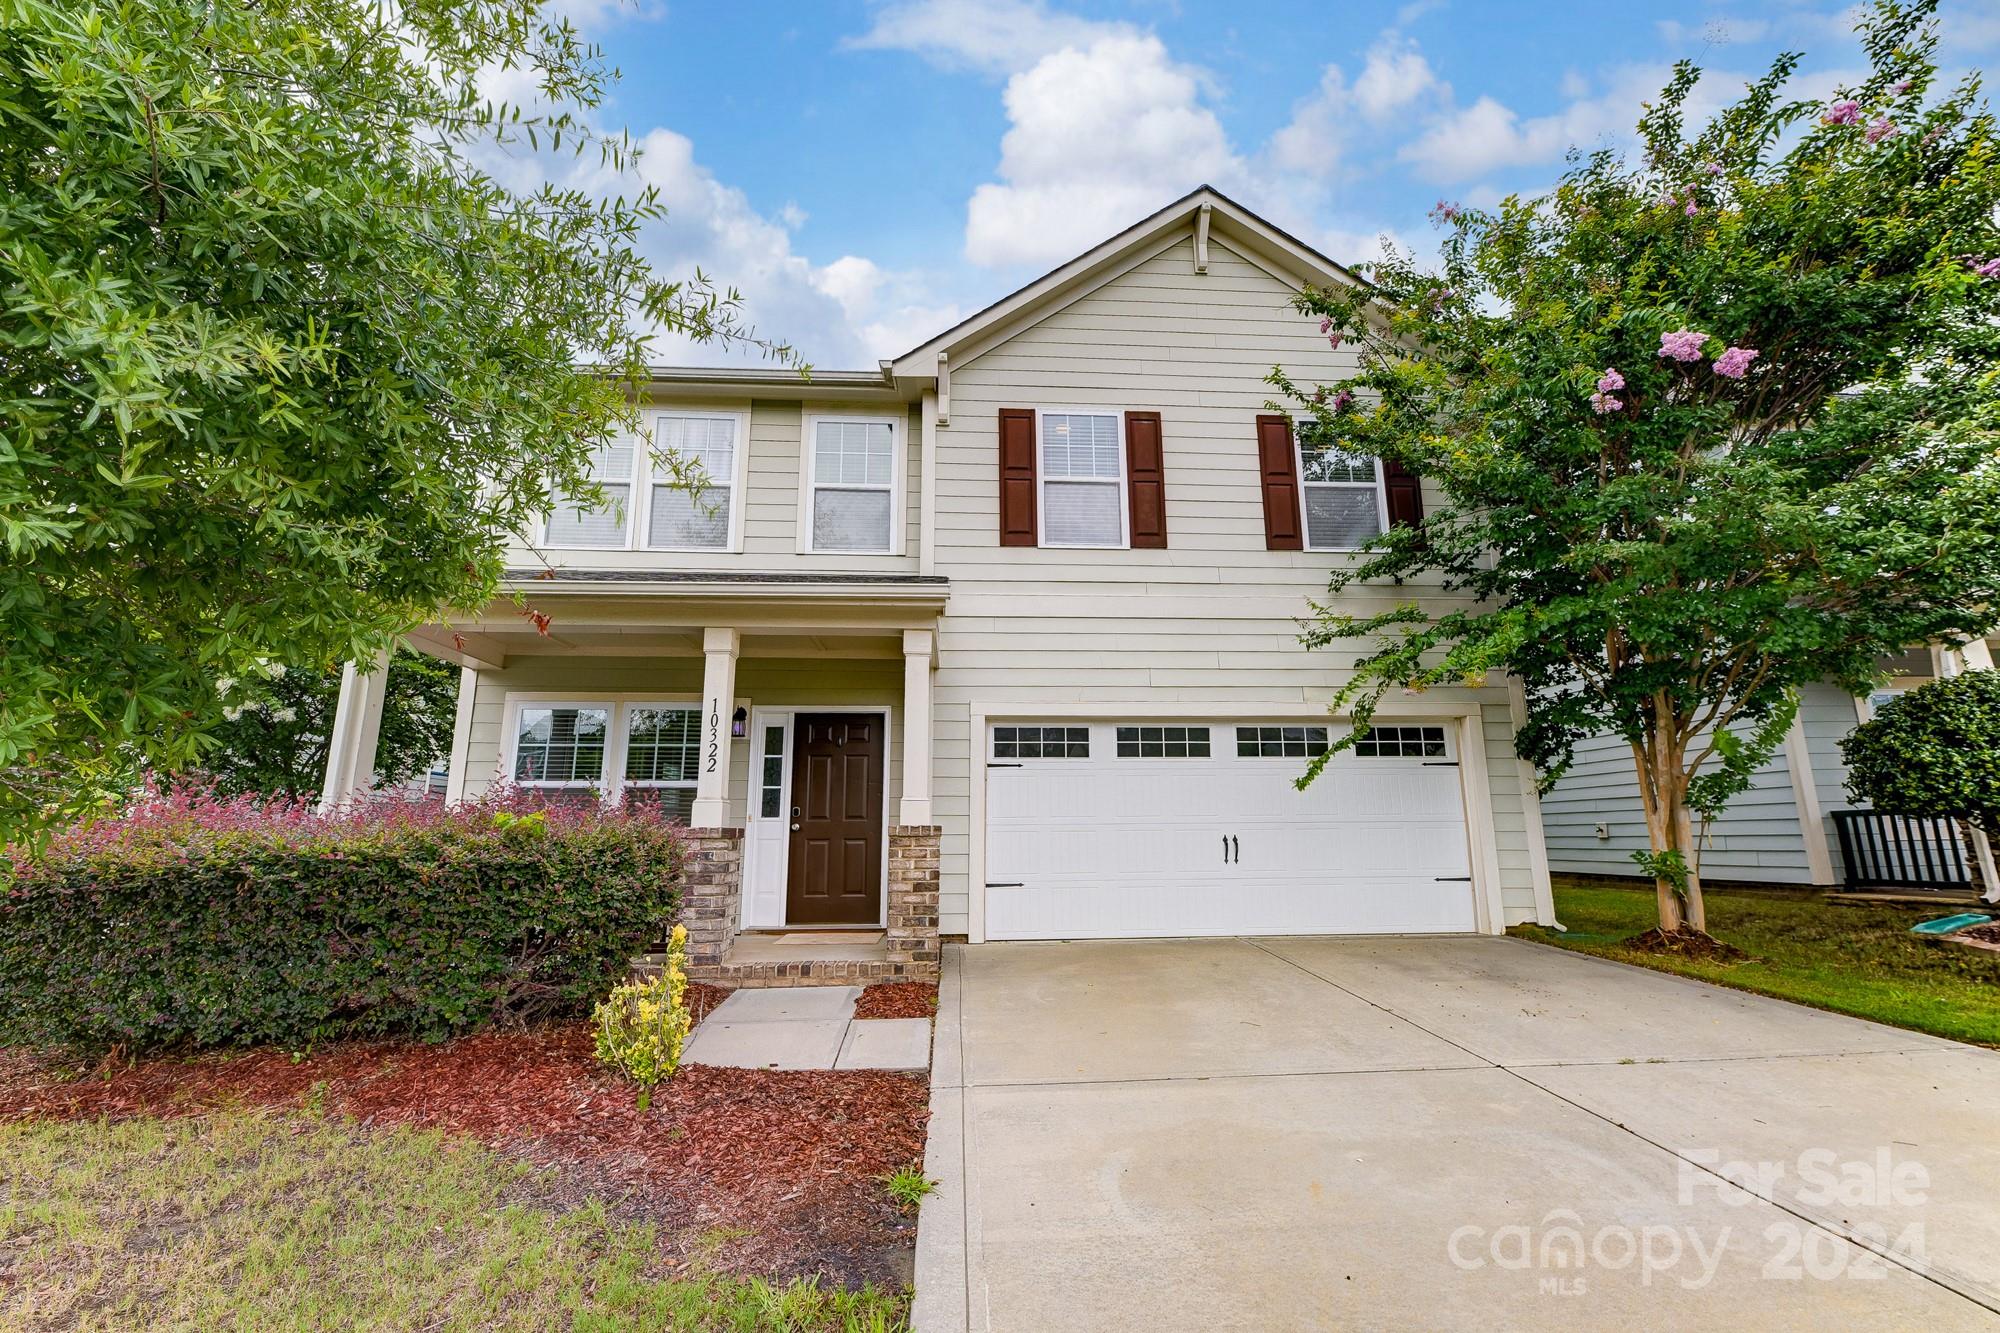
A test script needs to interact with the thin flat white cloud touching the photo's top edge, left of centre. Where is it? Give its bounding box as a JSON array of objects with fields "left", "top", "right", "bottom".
[{"left": 842, "top": 0, "right": 1138, "bottom": 74}]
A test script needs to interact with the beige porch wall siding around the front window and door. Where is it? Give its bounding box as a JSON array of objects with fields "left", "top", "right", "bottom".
[{"left": 466, "top": 656, "right": 902, "bottom": 829}]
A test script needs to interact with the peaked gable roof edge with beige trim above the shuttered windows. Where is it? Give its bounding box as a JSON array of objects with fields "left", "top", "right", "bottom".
[{"left": 882, "top": 184, "right": 1362, "bottom": 380}]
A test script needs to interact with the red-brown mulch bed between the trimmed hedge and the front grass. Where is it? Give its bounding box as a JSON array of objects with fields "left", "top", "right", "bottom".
[{"left": 0, "top": 1012, "right": 930, "bottom": 1285}]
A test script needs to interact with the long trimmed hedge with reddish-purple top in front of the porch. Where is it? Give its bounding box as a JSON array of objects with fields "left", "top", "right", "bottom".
[{"left": 0, "top": 789, "right": 684, "bottom": 1051}]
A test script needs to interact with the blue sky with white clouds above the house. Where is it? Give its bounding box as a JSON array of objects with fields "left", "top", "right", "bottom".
[{"left": 528, "top": 0, "right": 2000, "bottom": 368}]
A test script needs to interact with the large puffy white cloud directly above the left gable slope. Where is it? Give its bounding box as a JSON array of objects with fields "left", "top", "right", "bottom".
[{"left": 966, "top": 34, "right": 1248, "bottom": 266}]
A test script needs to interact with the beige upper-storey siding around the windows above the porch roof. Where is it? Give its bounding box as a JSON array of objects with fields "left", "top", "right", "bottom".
[{"left": 508, "top": 398, "right": 922, "bottom": 574}]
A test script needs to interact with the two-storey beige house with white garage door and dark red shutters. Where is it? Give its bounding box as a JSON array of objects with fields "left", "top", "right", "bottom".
[{"left": 316, "top": 188, "right": 1552, "bottom": 983}]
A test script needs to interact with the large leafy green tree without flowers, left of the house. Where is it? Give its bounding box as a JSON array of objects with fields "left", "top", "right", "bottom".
[{"left": 0, "top": 0, "right": 790, "bottom": 839}]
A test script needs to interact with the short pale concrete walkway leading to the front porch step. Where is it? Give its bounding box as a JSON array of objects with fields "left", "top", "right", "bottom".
[{"left": 686, "top": 987, "right": 930, "bottom": 1069}]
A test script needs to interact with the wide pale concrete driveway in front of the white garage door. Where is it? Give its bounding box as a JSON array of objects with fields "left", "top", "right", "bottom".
[{"left": 916, "top": 937, "right": 2000, "bottom": 1333}]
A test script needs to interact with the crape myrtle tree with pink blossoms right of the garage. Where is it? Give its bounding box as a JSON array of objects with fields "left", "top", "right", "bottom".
[{"left": 1272, "top": 4, "right": 2000, "bottom": 937}]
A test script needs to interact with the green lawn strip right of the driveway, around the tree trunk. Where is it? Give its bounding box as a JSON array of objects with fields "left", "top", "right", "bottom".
[{"left": 1512, "top": 883, "right": 2000, "bottom": 1047}]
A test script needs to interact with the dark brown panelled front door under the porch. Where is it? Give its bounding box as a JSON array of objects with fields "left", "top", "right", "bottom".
[{"left": 784, "top": 713, "right": 884, "bottom": 925}]
